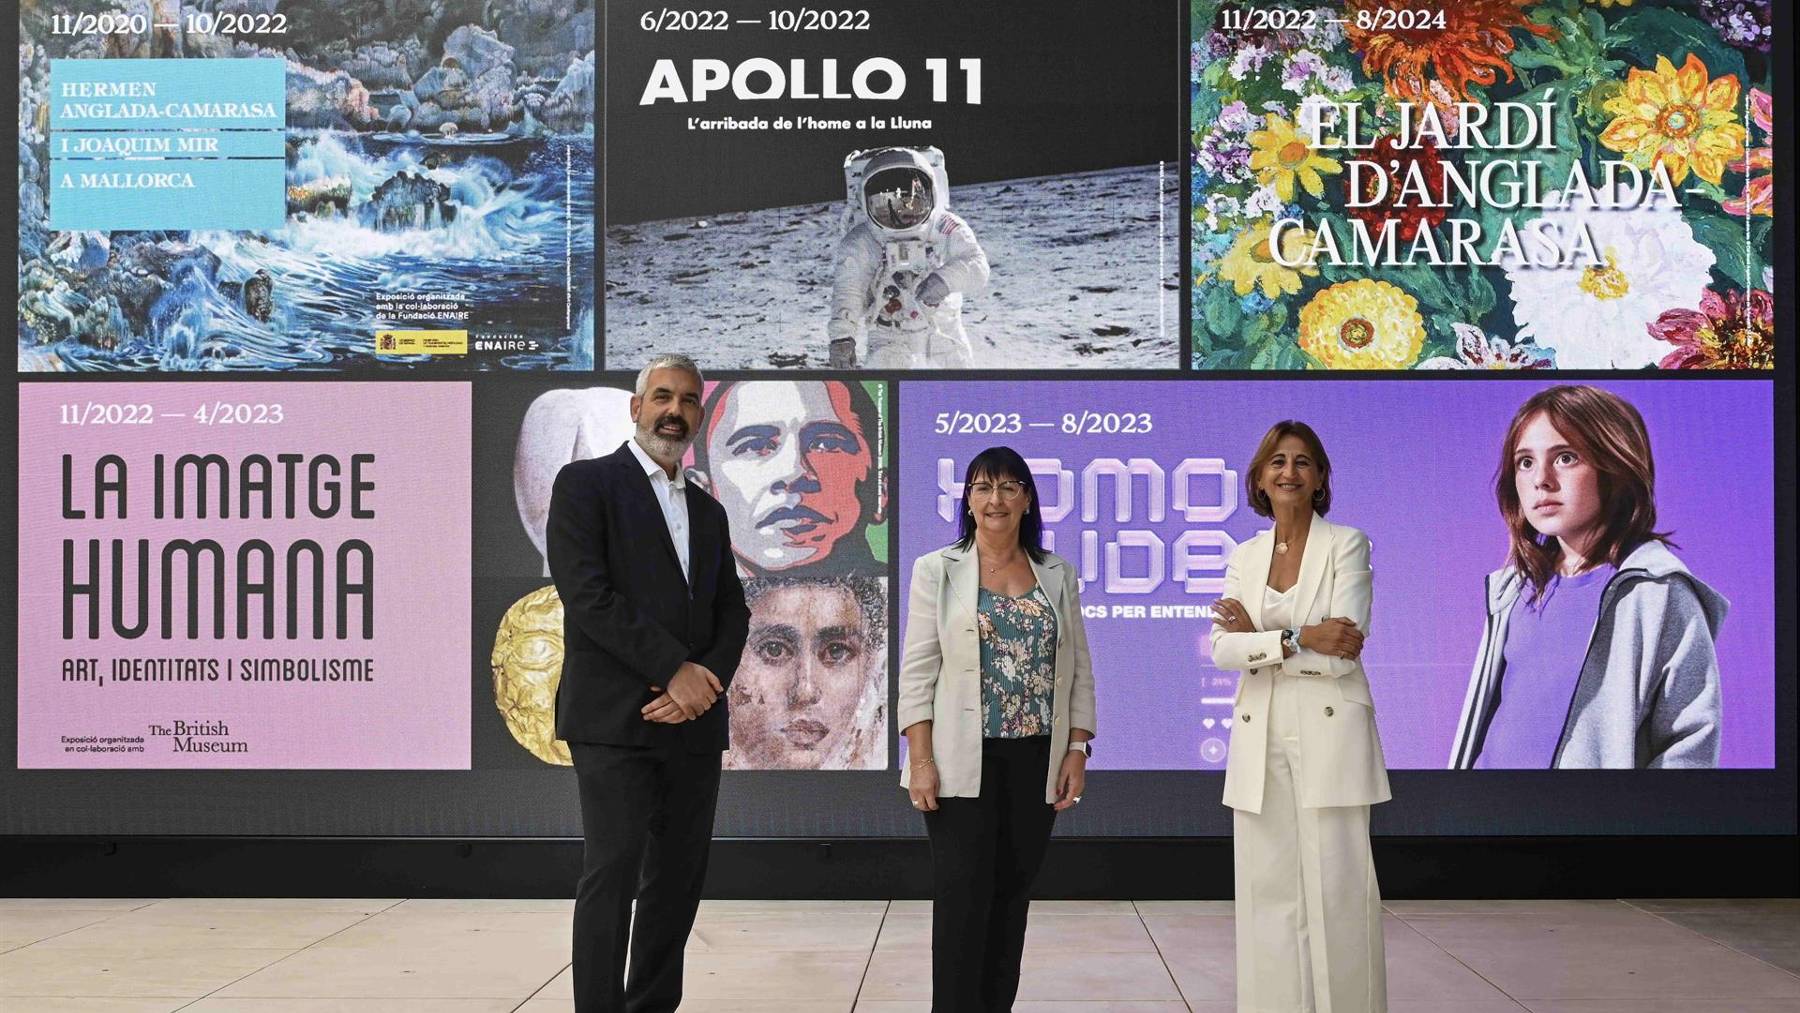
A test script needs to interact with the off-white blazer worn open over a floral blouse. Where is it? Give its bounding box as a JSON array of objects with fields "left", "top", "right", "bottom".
[{"left": 896, "top": 545, "right": 1098, "bottom": 802}]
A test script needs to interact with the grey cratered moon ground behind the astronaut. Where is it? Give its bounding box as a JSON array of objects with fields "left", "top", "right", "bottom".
[{"left": 605, "top": 166, "right": 1181, "bottom": 369}]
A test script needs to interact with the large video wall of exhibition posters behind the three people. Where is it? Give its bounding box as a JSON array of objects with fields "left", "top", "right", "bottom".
[{"left": 0, "top": 0, "right": 1796, "bottom": 837}]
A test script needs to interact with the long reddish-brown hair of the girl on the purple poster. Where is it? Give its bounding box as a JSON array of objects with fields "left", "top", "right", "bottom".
[{"left": 1494, "top": 385, "right": 1669, "bottom": 601}]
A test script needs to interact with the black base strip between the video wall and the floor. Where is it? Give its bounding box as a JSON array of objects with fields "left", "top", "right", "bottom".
[{"left": 0, "top": 837, "right": 1800, "bottom": 900}]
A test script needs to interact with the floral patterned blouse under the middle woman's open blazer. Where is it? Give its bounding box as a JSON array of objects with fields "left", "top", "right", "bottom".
[{"left": 976, "top": 587, "right": 1057, "bottom": 740}]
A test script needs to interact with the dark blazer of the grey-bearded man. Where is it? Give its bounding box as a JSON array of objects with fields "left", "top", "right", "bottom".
[{"left": 545, "top": 444, "right": 751, "bottom": 752}]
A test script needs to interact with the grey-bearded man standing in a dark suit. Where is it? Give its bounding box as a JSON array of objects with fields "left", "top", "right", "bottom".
[{"left": 545, "top": 354, "right": 751, "bottom": 1013}]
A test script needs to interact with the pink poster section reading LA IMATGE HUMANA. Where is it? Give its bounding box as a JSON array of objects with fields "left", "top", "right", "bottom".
[{"left": 18, "top": 383, "right": 470, "bottom": 770}]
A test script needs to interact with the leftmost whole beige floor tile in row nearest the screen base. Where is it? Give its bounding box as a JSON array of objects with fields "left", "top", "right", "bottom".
[{"left": 38, "top": 905, "right": 376, "bottom": 950}]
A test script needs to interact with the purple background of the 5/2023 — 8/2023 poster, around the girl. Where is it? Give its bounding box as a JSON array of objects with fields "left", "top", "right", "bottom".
[{"left": 898, "top": 380, "right": 1775, "bottom": 770}]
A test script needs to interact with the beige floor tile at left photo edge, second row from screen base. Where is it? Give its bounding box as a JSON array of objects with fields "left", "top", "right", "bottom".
[{"left": 0, "top": 946, "right": 292, "bottom": 999}]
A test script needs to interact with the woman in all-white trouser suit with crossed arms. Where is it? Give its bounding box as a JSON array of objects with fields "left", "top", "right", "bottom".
[{"left": 1211, "top": 421, "right": 1391, "bottom": 1013}]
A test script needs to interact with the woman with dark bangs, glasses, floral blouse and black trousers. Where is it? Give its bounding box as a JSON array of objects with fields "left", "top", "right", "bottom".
[{"left": 898, "top": 446, "right": 1094, "bottom": 1013}]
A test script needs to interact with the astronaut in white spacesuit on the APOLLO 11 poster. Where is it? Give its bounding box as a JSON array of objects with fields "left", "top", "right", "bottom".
[{"left": 826, "top": 148, "right": 988, "bottom": 369}]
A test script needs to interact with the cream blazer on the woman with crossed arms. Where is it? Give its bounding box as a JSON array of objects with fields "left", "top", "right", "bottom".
[{"left": 1211, "top": 515, "right": 1393, "bottom": 813}]
